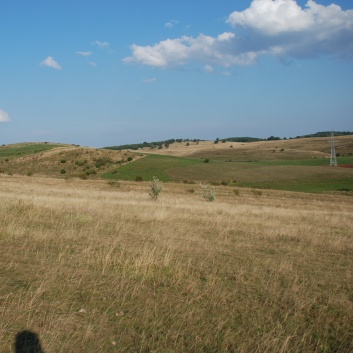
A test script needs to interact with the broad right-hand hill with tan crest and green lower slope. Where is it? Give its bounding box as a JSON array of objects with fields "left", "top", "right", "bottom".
[{"left": 103, "top": 136, "right": 353, "bottom": 192}]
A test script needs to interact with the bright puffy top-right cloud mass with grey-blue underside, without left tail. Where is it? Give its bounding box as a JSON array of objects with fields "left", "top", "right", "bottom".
[{"left": 227, "top": 0, "right": 353, "bottom": 58}]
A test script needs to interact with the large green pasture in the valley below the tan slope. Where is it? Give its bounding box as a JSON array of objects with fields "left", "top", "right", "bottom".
[{"left": 103, "top": 155, "right": 353, "bottom": 192}]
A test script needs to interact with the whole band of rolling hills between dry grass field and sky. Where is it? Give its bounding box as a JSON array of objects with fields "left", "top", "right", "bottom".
[{"left": 0, "top": 135, "right": 353, "bottom": 192}]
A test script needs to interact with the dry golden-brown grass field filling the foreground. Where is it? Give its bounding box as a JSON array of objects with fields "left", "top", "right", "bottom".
[{"left": 0, "top": 174, "right": 353, "bottom": 353}]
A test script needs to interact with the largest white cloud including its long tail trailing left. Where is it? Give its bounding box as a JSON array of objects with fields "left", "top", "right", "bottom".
[{"left": 123, "top": 0, "right": 353, "bottom": 71}]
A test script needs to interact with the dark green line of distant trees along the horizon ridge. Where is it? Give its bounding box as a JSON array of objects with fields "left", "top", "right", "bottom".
[{"left": 104, "top": 131, "right": 353, "bottom": 151}]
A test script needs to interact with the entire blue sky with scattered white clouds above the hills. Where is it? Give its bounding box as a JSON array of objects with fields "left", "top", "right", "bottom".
[{"left": 0, "top": 0, "right": 353, "bottom": 147}]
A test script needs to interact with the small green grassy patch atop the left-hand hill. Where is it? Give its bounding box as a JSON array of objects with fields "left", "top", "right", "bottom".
[{"left": 0, "top": 143, "right": 63, "bottom": 161}]
